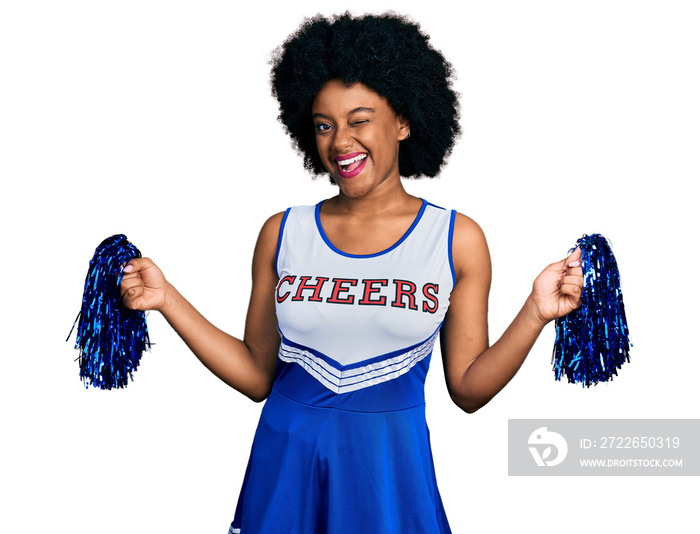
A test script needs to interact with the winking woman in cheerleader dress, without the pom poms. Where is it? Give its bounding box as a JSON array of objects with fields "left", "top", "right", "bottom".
[{"left": 122, "top": 15, "right": 583, "bottom": 534}]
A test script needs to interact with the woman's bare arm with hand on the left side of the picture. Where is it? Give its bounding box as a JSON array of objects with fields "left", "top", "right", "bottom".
[{"left": 121, "top": 214, "right": 282, "bottom": 401}]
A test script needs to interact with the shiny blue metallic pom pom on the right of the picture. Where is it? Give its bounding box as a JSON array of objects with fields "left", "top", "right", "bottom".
[{"left": 552, "top": 234, "right": 630, "bottom": 387}]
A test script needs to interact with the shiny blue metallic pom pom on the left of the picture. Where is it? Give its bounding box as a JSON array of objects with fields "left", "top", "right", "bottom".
[{"left": 66, "top": 234, "right": 151, "bottom": 389}]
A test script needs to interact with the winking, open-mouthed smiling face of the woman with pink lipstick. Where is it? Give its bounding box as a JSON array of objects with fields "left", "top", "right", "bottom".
[{"left": 311, "top": 80, "right": 409, "bottom": 198}]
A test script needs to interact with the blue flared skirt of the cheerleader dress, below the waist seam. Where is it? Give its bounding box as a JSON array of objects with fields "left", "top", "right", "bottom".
[{"left": 229, "top": 389, "right": 451, "bottom": 534}]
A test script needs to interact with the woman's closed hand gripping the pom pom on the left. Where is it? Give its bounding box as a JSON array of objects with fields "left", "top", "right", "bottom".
[{"left": 119, "top": 258, "right": 168, "bottom": 311}]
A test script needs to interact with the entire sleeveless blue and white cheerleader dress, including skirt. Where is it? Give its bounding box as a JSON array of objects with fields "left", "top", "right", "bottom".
[{"left": 229, "top": 200, "right": 455, "bottom": 534}]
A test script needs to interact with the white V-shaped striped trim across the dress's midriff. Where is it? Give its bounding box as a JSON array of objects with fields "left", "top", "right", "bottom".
[{"left": 279, "top": 331, "right": 438, "bottom": 393}]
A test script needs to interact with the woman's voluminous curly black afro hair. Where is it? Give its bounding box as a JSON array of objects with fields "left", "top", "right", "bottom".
[{"left": 271, "top": 13, "right": 460, "bottom": 178}]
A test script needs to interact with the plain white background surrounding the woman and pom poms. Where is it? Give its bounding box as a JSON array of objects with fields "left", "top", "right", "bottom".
[{"left": 0, "top": 0, "right": 700, "bottom": 534}]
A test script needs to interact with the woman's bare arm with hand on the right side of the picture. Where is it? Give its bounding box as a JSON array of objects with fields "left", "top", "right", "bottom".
[{"left": 441, "top": 215, "right": 583, "bottom": 413}]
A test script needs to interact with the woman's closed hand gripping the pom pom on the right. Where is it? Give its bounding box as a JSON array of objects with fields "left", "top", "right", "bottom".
[{"left": 530, "top": 248, "right": 583, "bottom": 323}]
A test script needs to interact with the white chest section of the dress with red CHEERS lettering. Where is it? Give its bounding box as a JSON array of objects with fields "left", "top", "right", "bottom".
[{"left": 275, "top": 203, "right": 453, "bottom": 365}]
